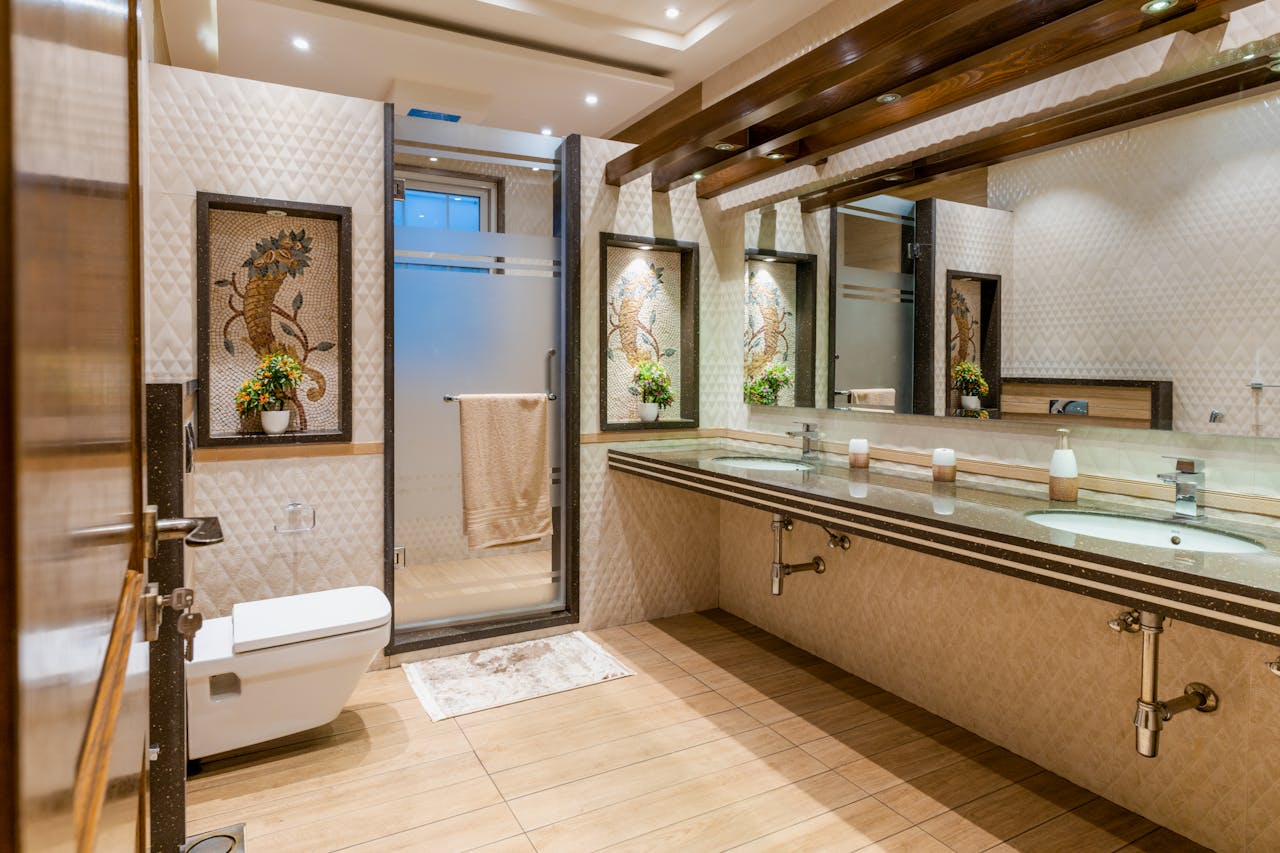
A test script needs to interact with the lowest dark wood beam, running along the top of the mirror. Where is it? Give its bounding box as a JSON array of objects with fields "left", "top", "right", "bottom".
[{"left": 800, "top": 55, "right": 1280, "bottom": 213}]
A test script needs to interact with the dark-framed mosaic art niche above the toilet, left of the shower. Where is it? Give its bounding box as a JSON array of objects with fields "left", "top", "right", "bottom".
[{"left": 196, "top": 192, "right": 351, "bottom": 447}]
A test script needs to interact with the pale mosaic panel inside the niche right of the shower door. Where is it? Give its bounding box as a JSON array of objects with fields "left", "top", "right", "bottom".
[{"left": 604, "top": 248, "right": 681, "bottom": 420}]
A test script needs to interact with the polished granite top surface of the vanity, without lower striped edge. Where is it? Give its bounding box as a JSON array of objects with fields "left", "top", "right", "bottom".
[{"left": 611, "top": 441, "right": 1280, "bottom": 602}]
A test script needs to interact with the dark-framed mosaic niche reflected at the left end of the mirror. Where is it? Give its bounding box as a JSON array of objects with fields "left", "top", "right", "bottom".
[{"left": 742, "top": 248, "right": 818, "bottom": 409}]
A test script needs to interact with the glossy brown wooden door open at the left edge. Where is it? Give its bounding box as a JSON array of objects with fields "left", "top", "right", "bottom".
[{"left": 0, "top": 0, "right": 147, "bottom": 850}]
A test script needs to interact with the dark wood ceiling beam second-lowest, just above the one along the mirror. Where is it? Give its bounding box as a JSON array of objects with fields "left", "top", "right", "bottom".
[{"left": 691, "top": 0, "right": 1257, "bottom": 199}]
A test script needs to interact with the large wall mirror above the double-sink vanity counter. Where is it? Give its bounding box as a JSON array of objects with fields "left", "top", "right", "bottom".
[{"left": 747, "top": 85, "right": 1280, "bottom": 435}]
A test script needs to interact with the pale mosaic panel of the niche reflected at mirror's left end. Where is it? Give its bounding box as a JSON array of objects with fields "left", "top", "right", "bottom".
[{"left": 742, "top": 260, "right": 796, "bottom": 406}]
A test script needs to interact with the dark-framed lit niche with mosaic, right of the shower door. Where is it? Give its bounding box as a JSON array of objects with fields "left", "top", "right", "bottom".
[{"left": 600, "top": 233, "right": 698, "bottom": 430}]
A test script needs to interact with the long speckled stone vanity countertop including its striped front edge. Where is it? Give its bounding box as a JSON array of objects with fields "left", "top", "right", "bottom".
[{"left": 609, "top": 441, "right": 1280, "bottom": 643}]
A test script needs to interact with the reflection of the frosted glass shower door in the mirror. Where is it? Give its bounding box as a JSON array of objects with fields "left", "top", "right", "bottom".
[{"left": 832, "top": 196, "right": 916, "bottom": 412}]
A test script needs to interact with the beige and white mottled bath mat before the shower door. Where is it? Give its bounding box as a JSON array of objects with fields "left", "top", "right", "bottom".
[{"left": 401, "top": 631, "right": 635, "bottom": 720}]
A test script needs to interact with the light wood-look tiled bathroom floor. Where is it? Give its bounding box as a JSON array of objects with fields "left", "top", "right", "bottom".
[{"left": 188, "top": 611, "right": 1203, "bottom": 853}]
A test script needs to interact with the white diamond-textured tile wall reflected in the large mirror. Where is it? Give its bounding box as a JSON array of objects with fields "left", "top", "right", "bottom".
[{"left": 989, "top": 95, "right": 1280, "bottom": 435}]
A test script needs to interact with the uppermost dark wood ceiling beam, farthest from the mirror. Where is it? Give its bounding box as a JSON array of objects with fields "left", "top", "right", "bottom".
[{"left": 604, "top": 0, "right": 1091, "bottom": 186}]
